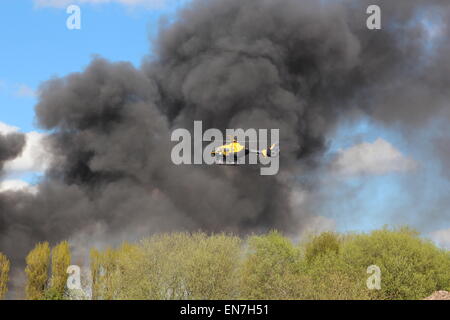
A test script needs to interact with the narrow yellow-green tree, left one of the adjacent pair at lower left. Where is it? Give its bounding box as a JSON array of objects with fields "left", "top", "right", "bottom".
[{"left": 25, "top": 242, "right": 50, "bottom": 300}]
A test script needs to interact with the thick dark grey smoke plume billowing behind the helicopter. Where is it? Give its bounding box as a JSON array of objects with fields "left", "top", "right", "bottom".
[{"left": 0, "top": 0, "right": 450, "bottom": 298}]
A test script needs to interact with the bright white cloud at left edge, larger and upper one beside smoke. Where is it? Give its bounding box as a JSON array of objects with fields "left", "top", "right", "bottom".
[{"left": 0, "top": 122, "right": 50, "bottom": 174}]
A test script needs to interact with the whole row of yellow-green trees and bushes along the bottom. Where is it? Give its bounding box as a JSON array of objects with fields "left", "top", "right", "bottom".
[{"left": 0, "top": 228, "right": 450, "bottom": 300}]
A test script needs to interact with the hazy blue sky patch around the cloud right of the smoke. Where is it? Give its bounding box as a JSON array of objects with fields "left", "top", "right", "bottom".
[{"left": 321, "top": 118, "right": 450, "bottom": 233}]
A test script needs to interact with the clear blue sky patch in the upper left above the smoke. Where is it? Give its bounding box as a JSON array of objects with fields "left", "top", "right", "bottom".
[{"left": 0, "top": 0, "right": 185, "bottom": 131}]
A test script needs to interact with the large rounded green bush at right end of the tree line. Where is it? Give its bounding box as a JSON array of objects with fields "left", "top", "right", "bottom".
[{"left": 342, "top": 228, "right": 450, "bottom": 299}]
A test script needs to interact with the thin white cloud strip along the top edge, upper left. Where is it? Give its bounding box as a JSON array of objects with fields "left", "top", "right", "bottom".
[{"left": 34, "top": 0, "right": 167, "bottom": 8}]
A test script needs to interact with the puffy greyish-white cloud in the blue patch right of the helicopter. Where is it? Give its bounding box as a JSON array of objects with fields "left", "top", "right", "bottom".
[{"left": 332, "top": 138, "right": 417, "bottom": 176}]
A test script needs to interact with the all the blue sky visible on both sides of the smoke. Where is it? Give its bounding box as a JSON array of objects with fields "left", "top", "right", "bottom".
[{"left": 0, "top": 0, "right": 450, "bottom": 240}]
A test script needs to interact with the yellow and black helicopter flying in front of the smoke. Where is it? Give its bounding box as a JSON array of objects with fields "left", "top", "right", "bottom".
[{"left": 211, "top": 137, "right": 279, "bottom": 164}]
